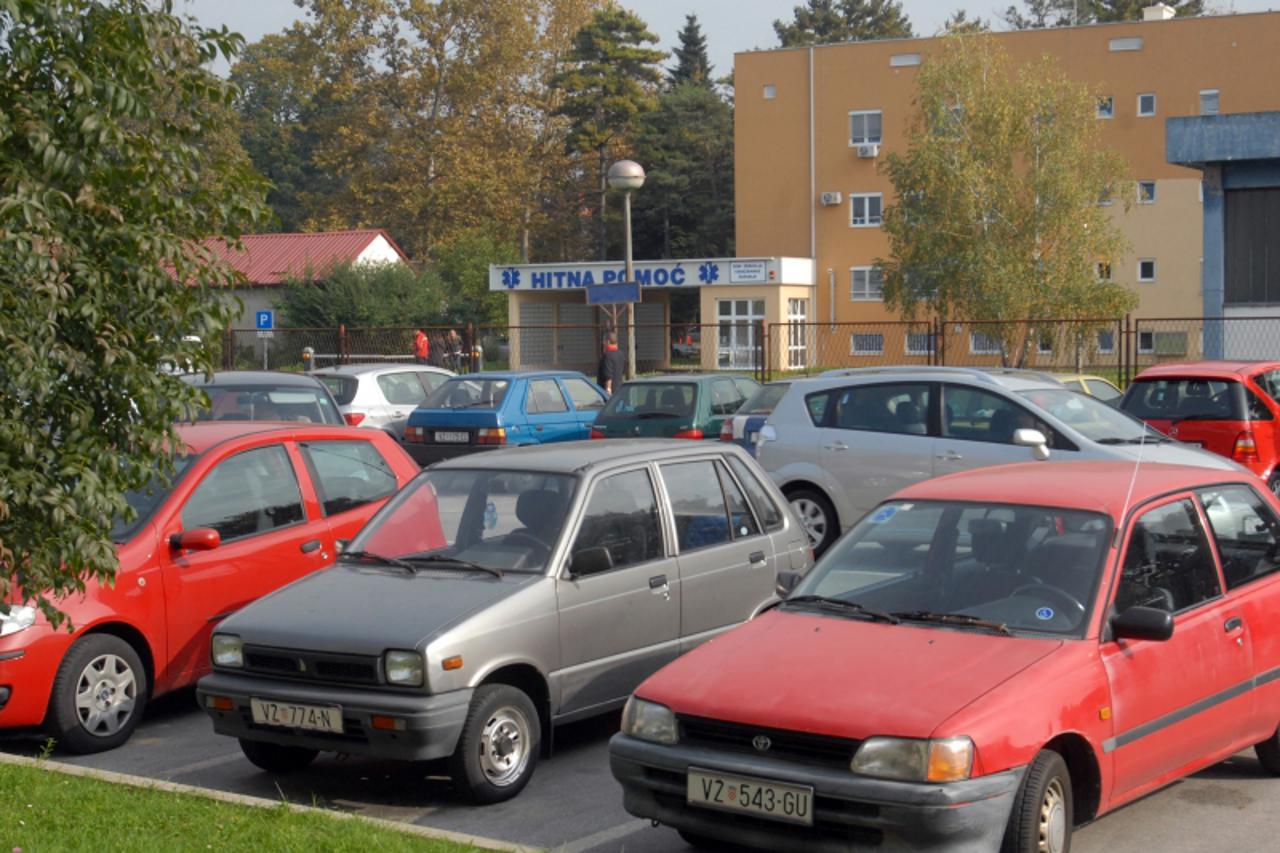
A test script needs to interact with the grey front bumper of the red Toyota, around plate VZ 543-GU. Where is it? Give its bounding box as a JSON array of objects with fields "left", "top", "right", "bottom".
[{"left": 609, "top": 734, "right": 1025, "bottom": 853}]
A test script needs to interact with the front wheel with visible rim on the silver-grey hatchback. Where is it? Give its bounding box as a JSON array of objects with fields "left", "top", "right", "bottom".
[{"left": 449, "top": 684, "right": 541, "bottom": 804}]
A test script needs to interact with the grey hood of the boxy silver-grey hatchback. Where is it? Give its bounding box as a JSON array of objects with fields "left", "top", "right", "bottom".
[{"left": 218, "top": 564, "right": 541, "bottom": 654}]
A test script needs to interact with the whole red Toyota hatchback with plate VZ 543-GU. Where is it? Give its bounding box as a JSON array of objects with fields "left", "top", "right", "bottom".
[{"left": 609, "top": 462, "right": 1280, "bottom": 853}]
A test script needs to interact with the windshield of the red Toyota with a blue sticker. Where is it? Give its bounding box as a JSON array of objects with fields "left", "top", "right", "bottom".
[{"left": 785, "top": 501, "right": 1111, "bottom": 637}]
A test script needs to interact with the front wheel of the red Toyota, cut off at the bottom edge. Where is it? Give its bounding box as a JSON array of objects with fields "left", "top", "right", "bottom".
[{"left": 1000, "top": 749, "right": 1075, "bottom": 853}]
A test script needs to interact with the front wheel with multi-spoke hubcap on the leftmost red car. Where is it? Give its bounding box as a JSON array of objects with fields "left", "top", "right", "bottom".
[{"left": 45, "top": 634, "right": 148, "bottom": 754}]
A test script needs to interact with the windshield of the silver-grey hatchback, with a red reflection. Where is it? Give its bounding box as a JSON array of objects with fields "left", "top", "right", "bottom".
[{"left": 347, "top": 469, "right": 577, "bottom": 573}]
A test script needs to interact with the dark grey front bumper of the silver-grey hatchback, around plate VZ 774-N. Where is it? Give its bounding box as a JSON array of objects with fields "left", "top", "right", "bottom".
[{"left": 196, "top": 672, "right": 472, "bottom": 761}]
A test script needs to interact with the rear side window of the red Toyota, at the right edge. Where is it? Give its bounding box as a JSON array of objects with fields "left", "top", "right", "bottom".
[{"left": 1198, "top": 485, "right": 1280, "bottom": 589}]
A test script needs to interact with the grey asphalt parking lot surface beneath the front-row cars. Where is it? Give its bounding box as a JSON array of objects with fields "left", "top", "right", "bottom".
[{"left": 0, "top": 690, "right": 1280, "bottom": 853}]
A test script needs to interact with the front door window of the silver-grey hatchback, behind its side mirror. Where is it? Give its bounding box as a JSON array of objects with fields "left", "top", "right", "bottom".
[{"left": 571, "top": 471, "right": 663, "bottom": 575}]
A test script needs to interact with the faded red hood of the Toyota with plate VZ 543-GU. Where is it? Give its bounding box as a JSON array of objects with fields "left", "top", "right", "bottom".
[{"left": 636, "top": 610, "right": 1062, "bottom": 740}]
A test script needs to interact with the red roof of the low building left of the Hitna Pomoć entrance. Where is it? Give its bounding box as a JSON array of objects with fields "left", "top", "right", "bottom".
[{"left": 205, "top": 228, "right": 408, "bottom": 286}]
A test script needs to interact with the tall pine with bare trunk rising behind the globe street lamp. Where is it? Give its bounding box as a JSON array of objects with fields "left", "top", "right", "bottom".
[{"left": 553, "top": 3, "right": 666, "bottom": 260}]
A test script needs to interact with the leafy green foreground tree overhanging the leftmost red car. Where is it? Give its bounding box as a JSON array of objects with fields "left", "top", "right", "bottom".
[{"left": 0, "top": 0, "right": 266, "bottom": 624}]
